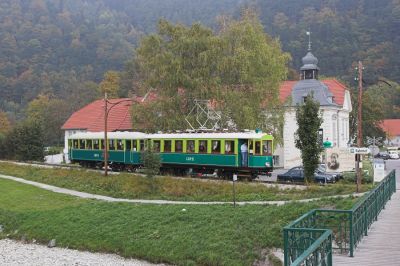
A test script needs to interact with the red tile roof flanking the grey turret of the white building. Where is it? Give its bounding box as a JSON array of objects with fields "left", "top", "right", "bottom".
[{"left": 279, "top": 79, "right": 346, "bottom": 105}]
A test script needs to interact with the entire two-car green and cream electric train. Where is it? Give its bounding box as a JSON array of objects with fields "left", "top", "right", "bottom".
[{"left": 69, "top": 132, "right": 273, "bottom": 178}]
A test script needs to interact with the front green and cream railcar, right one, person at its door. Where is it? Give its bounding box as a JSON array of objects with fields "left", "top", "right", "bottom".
[{"left": 151, "top": 132, "right": 273, "bottom": 176}]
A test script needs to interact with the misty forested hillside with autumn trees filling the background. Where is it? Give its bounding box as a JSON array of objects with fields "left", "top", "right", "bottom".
[{"left": 0, "top": 0, "right": 400, "bottom": 145}]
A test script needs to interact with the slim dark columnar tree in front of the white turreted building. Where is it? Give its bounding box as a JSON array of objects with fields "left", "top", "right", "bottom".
[{"left": 295, "top": 94, "right": 323, "bottom": 182}]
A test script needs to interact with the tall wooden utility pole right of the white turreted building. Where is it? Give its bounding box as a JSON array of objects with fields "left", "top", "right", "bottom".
[{"left": 356, "top": 61, "right": 363, "bottom": 193}]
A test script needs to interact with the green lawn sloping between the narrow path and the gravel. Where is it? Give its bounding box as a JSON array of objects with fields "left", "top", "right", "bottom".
[{"left": 0, "top": 179, "right": 355, "bottom": 265}]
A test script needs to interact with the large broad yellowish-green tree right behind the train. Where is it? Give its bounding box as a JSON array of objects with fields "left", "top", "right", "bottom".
[{"left": 133, "top": 10, "right": 290, "bottom": 137}]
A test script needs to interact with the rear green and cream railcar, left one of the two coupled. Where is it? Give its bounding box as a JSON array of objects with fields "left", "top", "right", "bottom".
[{"left": 68, "top": 132, "right": 147, "bottom": 170}]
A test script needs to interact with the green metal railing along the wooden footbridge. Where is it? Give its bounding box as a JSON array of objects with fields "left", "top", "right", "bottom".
[{"left": 283, "top": 170, "right": 396, "bottom": 266}]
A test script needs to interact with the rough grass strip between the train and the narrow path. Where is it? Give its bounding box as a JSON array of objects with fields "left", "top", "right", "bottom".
[{"left": 0, "top": 163, "right": 372, "bottom": 201}]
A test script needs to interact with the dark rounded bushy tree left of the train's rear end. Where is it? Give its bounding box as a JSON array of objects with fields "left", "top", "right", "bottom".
[{"left": 6, "top": 120, "right": 44, "bottom": 161}]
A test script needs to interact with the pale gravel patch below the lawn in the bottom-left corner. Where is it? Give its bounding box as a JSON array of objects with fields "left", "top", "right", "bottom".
[{"left": 0, "top": 239, "right": 164, "bottom": 266}]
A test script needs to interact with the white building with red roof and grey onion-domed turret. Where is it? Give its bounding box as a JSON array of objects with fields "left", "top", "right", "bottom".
[{"left": 275, "top": 47, "right": 352, "bottom": 170}]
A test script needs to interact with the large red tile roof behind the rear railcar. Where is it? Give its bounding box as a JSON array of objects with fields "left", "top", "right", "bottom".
[{"left": 61, "top": 97, "right": 136, "bottom": 132}]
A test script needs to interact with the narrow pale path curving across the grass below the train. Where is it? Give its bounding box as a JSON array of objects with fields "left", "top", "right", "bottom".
[{"left": 0, "top": 174, "right": 364, "bottom": 206}]
